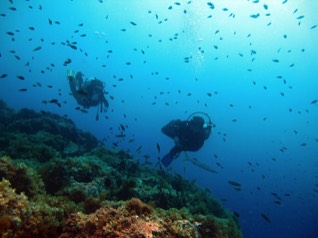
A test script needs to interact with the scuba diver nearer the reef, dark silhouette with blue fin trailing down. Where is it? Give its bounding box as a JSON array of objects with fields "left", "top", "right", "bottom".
[{"left": 161, "top": 112, "right": 213, "bottom": 167}]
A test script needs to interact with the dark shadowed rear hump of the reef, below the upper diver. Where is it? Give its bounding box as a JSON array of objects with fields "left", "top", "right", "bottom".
[{"left": 0, "top": 102, "right": 98, "bottom": 158}]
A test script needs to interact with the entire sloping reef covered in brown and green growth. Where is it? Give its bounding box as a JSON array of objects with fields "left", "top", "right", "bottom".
[{"left": 0, "top": 100, "right": 242, "bottom": 238}]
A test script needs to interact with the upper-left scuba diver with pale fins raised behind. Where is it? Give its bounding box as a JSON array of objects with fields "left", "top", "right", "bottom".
[{"left": 66, "top": 70, "right": 109, "bottom": 120}]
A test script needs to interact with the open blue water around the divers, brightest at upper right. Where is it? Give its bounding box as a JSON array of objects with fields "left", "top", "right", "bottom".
[{"left": 0, "top": 0, "right": 318, "bottom": 238}]
